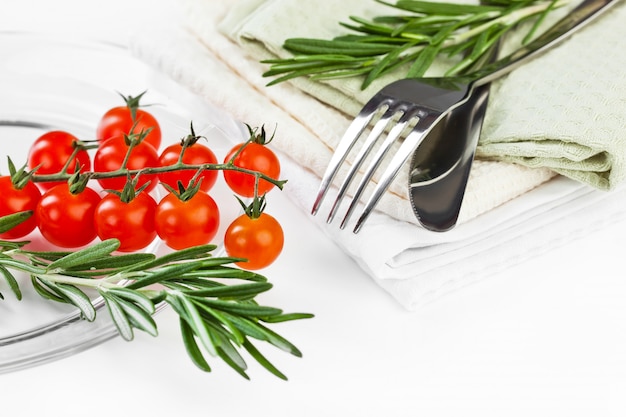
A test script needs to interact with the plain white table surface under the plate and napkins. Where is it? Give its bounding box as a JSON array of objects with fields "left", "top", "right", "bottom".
[{"left": 0, "top": 0, "right": 626, "bottom": 417}]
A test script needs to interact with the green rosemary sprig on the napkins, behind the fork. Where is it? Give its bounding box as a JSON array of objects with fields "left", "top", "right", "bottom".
[{"left": 262, "top": 0, "right": 571, "bottom": 89}]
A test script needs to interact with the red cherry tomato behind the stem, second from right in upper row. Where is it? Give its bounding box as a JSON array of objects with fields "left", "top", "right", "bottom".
[{"left": 159, "top": 142, "right": 217, "bottom": 192}]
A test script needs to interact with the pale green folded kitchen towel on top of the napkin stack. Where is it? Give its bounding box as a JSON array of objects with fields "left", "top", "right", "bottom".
[{"left": 220, "top": 0, "right": 626, "bottom": 190}]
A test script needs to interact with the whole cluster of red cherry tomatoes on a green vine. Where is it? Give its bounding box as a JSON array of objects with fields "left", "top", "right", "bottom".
[{"left": 0, "top": 92, "right": 284, "bottom": 269}]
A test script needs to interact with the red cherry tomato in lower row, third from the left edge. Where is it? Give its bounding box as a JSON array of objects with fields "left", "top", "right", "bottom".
[{"left": 94, "top": 192, "right": 157, "bottom": 252}]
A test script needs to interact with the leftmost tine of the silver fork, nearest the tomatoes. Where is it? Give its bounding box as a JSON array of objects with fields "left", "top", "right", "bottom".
[{"left": 311, "top": 96, "right": 385, "bottom": 215}]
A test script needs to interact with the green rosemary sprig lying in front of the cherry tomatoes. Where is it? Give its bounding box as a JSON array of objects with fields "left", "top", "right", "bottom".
[{"left": 0, "top": 224, "right": 313, "bottom": 379}]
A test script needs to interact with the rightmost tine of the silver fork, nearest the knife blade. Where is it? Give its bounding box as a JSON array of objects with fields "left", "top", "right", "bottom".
[{"left": 353, "top": 112, "right": 443, "bottom": 233}]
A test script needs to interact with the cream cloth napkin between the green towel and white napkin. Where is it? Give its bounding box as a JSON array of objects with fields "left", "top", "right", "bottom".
[{"left": 169, "top": 0, "right": 554, "bottom": 228}]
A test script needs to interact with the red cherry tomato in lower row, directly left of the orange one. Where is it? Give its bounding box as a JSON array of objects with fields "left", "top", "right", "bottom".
[{"left": 155, "top": 191, "right": 220, "bottom": 249}]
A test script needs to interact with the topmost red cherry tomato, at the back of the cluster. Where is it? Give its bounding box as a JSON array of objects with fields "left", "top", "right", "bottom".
[{"left": 96, "top": 106, "right": 161, "bottom": 149}]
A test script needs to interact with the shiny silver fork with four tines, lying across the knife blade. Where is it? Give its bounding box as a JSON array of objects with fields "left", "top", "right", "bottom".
[{"left": 312, "top": 0, "right": 619, "bottom": 233}]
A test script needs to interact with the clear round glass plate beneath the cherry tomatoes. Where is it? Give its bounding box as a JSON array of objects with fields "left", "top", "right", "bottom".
[{"left": 0, "top": 32, "right": 245, "bottom": 373}]
